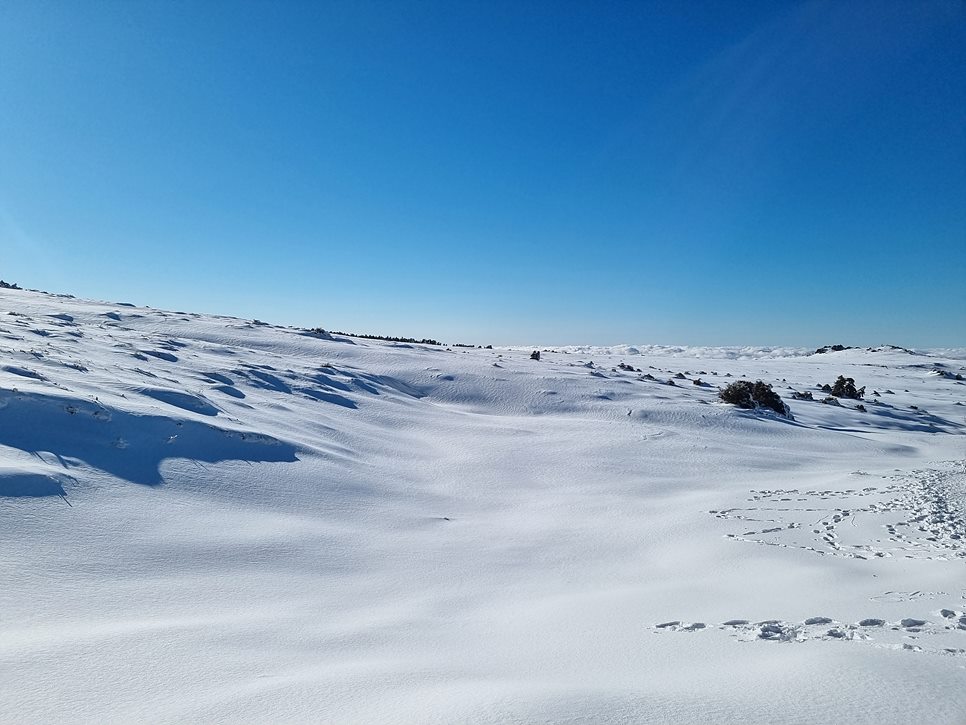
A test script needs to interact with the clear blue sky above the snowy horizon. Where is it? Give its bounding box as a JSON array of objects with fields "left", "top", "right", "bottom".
[{"left": 0, "top": 0, "right": 966, "bottom": 346}]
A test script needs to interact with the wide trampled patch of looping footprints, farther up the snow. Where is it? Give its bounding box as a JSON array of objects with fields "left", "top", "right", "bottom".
[{"left": 709, "top": 463, "right": 966, "bottom": 562}]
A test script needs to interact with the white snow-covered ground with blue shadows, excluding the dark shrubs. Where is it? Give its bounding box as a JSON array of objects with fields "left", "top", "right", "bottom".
[{"left": 0, "top": 290, "right": 966, "bottom": 724}]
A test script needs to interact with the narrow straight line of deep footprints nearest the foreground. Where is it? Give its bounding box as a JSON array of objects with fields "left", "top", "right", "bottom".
[{"left": 652, "top": 609, "right": 966, "bottom": 657}]
